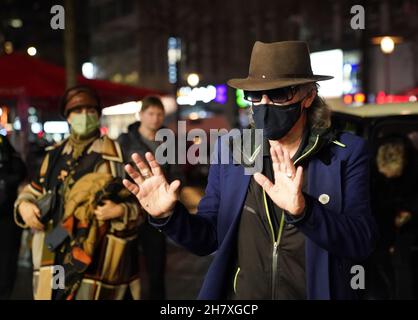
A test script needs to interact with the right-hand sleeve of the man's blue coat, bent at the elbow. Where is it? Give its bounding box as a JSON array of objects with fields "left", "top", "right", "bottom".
[{"left": 286, "top": 142, "right": 377, "bottom": 261}]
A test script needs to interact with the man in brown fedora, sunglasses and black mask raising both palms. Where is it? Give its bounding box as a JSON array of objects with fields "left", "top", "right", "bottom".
[{"left": 124, "top": 41, "right": 376, "bottom": 299}]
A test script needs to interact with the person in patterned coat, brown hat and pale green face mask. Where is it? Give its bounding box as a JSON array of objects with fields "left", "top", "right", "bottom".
[{"left": 15, "top": 86, "right": 140, "bottom": 300}]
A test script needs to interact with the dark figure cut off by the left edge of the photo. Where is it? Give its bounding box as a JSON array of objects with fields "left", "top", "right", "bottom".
[{"left": 0, "top": 128, "right": 26, "bottom": 300}]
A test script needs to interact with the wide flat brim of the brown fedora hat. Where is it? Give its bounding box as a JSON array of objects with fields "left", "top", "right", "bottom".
[{"left": 227, "top": 75, "right": 334, "bottom": 91}]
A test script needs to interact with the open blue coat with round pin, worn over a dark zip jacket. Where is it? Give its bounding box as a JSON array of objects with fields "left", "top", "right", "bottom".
[{"left": 151, "top": 133, "right": 377, "bottom": 299}]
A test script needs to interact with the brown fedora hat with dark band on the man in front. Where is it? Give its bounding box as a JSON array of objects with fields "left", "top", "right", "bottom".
[{"left": 227, "top": 41, "right": 333, "bottom": 91}]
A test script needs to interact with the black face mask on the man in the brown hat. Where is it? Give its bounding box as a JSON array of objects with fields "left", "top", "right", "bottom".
[{"left": 253, "top": 101, "right": 302, "bottom": 140}]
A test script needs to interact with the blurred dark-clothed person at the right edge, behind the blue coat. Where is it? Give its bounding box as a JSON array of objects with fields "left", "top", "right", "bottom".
[{"left": 371, "top": 135, "right": 418, "bottom": 299}]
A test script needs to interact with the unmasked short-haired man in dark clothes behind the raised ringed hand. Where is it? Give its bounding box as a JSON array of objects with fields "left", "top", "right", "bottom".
[{"left": 118, "top": 96, "right": 184, "bottom": 300}]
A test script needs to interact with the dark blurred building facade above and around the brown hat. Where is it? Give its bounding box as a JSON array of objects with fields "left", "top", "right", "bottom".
[{"left": 90, "top": 0, "right": 418, "bottom": 95}]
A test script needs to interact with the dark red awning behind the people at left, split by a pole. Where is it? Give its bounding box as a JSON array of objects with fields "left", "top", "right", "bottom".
[{"left": 0, "top": 53, "right": 163, "bottom": 107}]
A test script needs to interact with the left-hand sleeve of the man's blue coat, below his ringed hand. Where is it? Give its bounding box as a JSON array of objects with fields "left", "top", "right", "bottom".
[{"left": 149, "top": 139, "right": 221, "bottom": 256}]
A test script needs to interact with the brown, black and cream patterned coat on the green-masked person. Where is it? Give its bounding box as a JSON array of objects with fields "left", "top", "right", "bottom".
[{"left": 14, "top": 136, "right": 141, "bottom": 300}]
